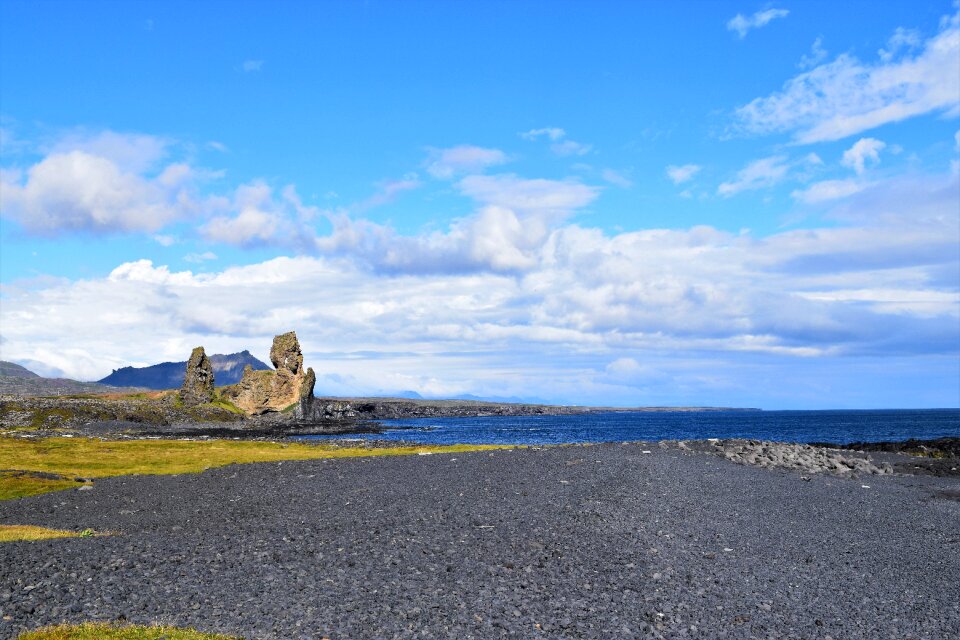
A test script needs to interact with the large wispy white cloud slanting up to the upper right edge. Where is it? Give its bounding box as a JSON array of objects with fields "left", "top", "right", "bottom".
[{"left": 736, "top": 10, "right": 960, "bottom": 144}]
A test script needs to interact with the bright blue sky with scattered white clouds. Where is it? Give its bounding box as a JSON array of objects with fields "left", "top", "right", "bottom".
[{"left": 0, "top": 0, "right": 960, "bottom": 409}]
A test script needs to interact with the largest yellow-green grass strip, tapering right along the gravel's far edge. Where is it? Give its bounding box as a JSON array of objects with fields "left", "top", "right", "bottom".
[{"left": 0, "top": 436, "right": 513, "bottom": 499}]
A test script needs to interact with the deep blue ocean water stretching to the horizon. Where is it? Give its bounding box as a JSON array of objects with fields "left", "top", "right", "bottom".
[{"left": 302, "top": 409, "right": 960, "bottom": 444}]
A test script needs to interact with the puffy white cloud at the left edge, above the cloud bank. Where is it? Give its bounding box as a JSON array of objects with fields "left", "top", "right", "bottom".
[{"left": 0, "top": 151, "right": 195, "bottom": 235}]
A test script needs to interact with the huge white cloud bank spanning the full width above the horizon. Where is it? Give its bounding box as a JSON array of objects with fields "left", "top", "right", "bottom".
[{"left": 0, "top": 168, "right": 960, "bottom": 403}]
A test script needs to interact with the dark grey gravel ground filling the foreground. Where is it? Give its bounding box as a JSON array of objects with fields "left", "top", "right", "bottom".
[{"left": 0, "top": 443, "right": 960, "bottom": 640}]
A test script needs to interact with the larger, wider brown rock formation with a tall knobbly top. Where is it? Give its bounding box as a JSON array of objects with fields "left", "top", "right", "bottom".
[{"left": 223, "top": 331, "right": 317, "bottom": 415}]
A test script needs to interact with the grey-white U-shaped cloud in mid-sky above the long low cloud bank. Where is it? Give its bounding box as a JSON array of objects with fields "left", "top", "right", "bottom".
[{"left": 194, "top": 169, "right": 599, "bottom": 273}]
